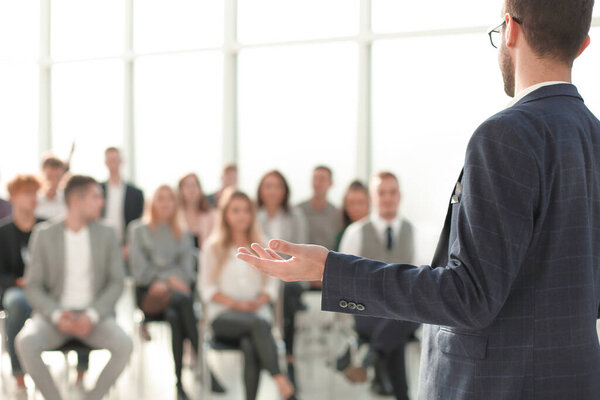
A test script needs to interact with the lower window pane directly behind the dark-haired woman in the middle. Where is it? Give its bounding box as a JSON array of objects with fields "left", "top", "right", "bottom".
[{"left": 239, "top": 44, "right": 357, "bottom": 203}]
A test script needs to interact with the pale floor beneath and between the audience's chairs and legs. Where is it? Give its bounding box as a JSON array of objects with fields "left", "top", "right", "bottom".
[{"left": 0, "top": 287, "right": 600, "bottom": 400}]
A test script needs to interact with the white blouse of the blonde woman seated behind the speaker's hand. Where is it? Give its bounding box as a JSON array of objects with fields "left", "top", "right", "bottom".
[{"left": 199, "top": 245, "right": 279, "bottom": 321}]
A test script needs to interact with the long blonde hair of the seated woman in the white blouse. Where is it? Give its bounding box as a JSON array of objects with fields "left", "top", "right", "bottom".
[{"left": 207, "top": 188, "right": 264, "bottom": 280}]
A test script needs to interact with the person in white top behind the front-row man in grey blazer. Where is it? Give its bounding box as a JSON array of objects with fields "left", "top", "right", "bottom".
[{"left": 35, "top": 155, "right": 67, "bottom": 219}]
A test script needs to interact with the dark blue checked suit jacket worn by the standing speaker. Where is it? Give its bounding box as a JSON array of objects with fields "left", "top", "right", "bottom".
[{"left": 322, "top": 84, "right": 600, "bottom": 400}]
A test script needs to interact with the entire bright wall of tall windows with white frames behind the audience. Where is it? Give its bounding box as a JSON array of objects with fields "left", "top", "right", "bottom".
[{"left": 0, "top": 0, "right": 600, "bottom": 253}]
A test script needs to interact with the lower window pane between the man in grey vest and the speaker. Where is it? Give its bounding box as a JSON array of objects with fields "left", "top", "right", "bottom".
[{"left": 373, "top": 35, "right": 510, "bottom": 262}]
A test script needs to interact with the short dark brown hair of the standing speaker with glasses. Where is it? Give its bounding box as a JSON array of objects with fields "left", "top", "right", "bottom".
[{"left": 505, "top": 0, "right": 594, "bottom": 65}]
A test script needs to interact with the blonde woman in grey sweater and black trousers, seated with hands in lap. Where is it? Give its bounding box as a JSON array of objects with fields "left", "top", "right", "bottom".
[{"left": 129, "top": 185, "right": 224, "bottom": 400}]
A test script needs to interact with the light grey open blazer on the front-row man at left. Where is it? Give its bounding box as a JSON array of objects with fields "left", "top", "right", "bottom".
[{"left": 25, "top": 220, "right": 125, "bottom": 320}]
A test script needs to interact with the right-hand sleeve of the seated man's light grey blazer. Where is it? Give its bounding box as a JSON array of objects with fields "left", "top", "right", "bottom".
[{"left": 90, "top": 229, "right": 125, "bottom": 319}]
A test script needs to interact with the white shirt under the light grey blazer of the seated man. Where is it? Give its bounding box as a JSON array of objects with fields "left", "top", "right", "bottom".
[{"left": 52, "top": 226, "right": 99, "bottom": 323}]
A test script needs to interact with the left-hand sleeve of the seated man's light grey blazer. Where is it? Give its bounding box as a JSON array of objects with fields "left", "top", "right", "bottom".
[{"left": 25, "top": 226, "right": 60, "bottom": 320}]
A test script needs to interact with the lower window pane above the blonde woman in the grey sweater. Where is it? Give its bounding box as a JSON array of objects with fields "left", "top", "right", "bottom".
[{"left": 135, "top": 52, "right": 222, "bottom": 196}]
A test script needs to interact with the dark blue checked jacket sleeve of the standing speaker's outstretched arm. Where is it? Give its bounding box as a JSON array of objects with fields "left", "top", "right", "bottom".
[{"left": 322, "top": 116, "right": 539, "bottom": 329}]
